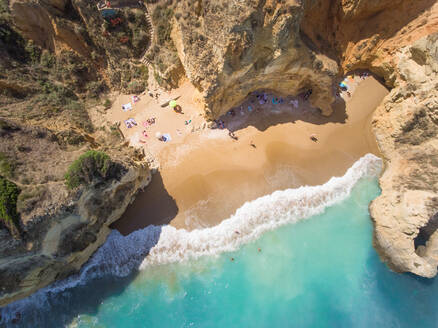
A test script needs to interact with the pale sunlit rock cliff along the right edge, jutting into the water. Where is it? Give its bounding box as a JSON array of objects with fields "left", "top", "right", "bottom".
[{"left": 370, "top": 33, "right": 438, "bottom": 277}]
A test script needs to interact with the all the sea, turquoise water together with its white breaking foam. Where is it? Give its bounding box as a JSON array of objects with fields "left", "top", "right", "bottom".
[{"left": 0, "top": 155, "right": 438, "bottom": 327}]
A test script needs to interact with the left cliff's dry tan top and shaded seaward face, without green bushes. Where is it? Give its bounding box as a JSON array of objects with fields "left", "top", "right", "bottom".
[{"left": 0, "top": 120, "right": 151, "bottom": 306}]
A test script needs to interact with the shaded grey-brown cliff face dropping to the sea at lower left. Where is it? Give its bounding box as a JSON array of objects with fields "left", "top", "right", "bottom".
[{"left": 0, "top": 163, "right": 151, "bottom": 306}]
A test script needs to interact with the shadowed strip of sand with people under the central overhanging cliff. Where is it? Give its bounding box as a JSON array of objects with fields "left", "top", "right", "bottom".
[{"left": 218, "top": 89, "right": 348, "bottom": 132}]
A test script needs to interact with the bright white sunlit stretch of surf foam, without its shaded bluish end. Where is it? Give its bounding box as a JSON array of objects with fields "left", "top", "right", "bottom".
[{"left": 140, "top": 154, "right": 381, "bottom": 269}]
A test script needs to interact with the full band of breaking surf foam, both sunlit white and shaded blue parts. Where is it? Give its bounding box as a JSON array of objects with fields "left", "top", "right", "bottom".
[{"left": 0, "top": 154, "right": 382, "bottom": 324}]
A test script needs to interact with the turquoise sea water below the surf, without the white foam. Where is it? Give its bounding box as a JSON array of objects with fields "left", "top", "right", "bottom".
[{"left": 0, "top": 173, "right": 438, "bottom": 327}]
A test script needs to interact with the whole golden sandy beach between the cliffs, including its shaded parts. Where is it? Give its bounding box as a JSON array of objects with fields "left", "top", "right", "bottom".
[{"left": 106, "top": 76, "right": 388, "bottom": 234}]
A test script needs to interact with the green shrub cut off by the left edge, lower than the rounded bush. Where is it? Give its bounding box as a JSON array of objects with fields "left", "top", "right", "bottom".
[{"left": 0, "top": 176, "right": 20, "bottom": 238}]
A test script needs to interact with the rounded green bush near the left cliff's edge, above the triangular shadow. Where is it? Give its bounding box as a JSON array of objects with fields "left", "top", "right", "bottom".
[{"left": 65, "top": 150, "right": 112, "bottom": 189}]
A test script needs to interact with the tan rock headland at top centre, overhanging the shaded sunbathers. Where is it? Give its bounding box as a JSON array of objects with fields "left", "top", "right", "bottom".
[{"left": 173, "top": 0, "right": 337, "bottom": 118}]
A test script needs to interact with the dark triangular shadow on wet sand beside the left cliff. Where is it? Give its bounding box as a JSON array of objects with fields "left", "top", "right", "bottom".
[{"left": 110, "top": 171, "right": 178, "bottom": 236}]
